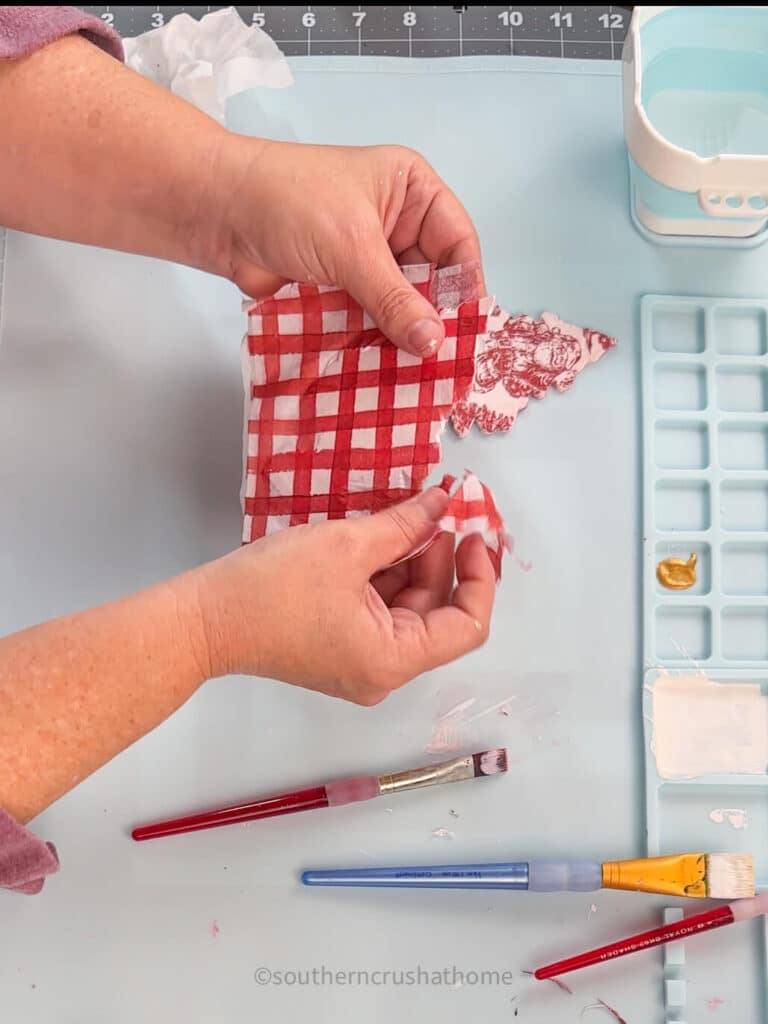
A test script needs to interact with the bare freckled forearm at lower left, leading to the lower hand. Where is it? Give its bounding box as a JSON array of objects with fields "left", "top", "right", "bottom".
[{"left": 0, "top": 573, "right": 211, "bottom": 823}]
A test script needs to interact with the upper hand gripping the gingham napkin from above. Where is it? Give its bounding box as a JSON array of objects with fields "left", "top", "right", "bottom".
[{"left": 214, "top": 136, "right": 480, "bottom": 356}]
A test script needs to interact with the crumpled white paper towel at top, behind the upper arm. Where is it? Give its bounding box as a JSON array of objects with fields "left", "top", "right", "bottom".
[{"left": 123, "top": 7, "right": 293, "bottom": 124}]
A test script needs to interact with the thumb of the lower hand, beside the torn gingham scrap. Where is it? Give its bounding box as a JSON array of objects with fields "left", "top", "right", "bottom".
[{"left": 352, "top": 487, "right": 450, "bottom": 574}]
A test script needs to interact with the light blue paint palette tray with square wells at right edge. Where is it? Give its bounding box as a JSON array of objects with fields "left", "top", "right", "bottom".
[{"left": 640, "top": 295, "right": 768, "bottom": 1024}]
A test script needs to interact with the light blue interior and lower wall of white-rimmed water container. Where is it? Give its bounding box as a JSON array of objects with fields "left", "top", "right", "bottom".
[{"left": 630, "top": 7, "right": 768, "bottom": 234}]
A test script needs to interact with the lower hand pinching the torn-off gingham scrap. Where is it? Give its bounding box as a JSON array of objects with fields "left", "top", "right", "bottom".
[{"left": 189, "top": 487, "right": 496, "bottom": 706}]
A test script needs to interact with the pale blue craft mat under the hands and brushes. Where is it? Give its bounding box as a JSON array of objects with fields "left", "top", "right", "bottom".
[{"left": 0, "top": 57, "right": 766, "bottom": 1024}]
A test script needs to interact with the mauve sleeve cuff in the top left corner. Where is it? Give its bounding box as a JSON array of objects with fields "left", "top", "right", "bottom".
[{"left": 0, "top": 7, "right": 124, "bottom": 60}]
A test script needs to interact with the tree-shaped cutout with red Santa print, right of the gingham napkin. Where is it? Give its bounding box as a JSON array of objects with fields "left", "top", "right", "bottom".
[{"left": 451, "top": 306, "right": 616, "bottom": 437}]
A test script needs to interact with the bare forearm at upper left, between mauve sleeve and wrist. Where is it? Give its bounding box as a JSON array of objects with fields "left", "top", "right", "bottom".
[{"left": 0, "top": 36, "right": 243, "bottom": 272}]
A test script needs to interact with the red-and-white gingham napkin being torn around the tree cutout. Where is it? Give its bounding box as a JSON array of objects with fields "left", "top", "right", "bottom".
[{"left": 244, "top": 265, "right": 501, "bottom": 543}]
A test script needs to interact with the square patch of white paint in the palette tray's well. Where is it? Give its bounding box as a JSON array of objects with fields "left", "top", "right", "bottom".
[{"left": 651, "top": 676, "right": 768, "bottom": 778}]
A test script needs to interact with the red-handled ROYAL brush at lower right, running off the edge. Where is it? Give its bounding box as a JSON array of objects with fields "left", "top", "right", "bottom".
[{"left": 534, "top": 893, "right": 768, "bottom": 981}]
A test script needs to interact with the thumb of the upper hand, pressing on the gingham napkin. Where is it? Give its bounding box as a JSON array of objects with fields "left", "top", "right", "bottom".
[{"left": 344, "top": 232, "right": 445, "bottom": 358}]
